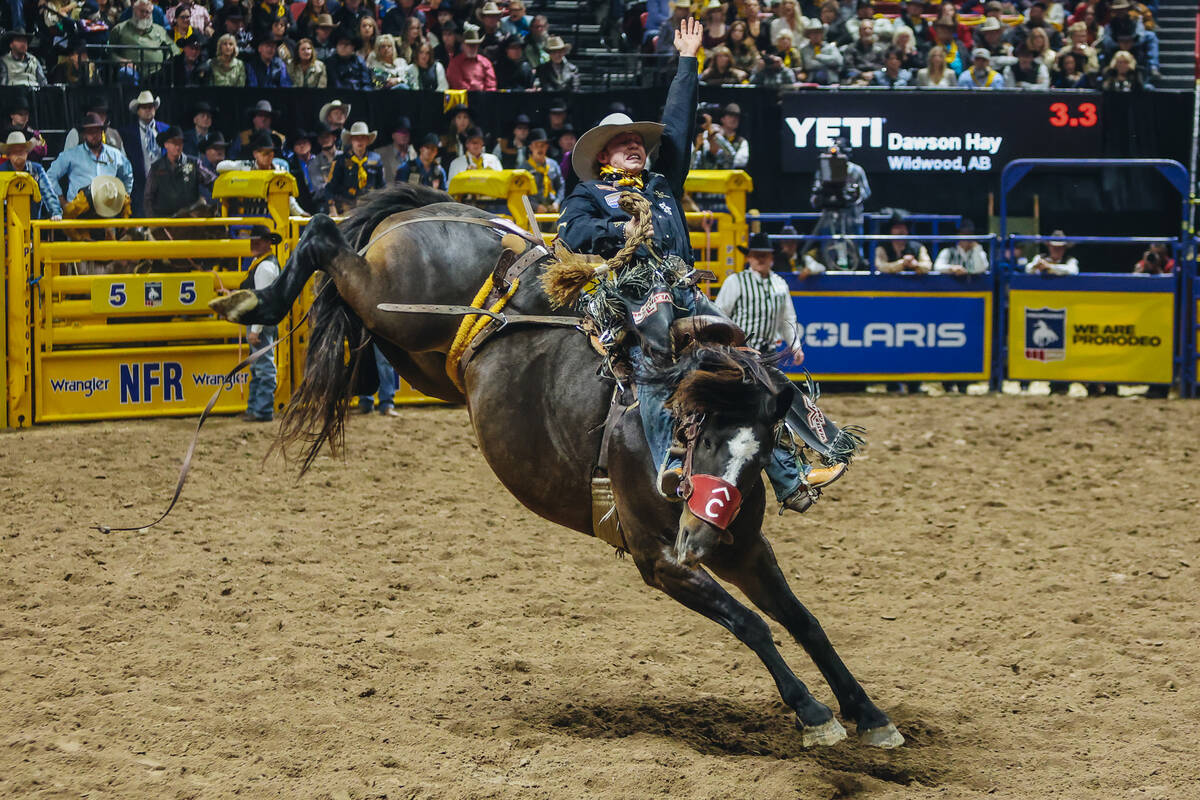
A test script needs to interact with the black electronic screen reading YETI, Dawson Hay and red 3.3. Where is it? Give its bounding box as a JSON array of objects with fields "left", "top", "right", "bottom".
[{"left": 781, "top": 89, "right": 1103, "bottom": 175}]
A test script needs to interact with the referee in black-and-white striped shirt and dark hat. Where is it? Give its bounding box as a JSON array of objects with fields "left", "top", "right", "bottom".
[{"left": 716, "top": 234, "right": 804, "bottom": 365}]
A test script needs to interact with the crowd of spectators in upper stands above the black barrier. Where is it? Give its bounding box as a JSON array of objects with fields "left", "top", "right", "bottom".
[{"left": 0, "top": 0, "right": 1159, "bottom": 92}]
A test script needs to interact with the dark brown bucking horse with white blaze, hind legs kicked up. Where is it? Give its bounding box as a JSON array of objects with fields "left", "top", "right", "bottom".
[{"left": 214, "top": 185, "right": 904, "bottom": 747}]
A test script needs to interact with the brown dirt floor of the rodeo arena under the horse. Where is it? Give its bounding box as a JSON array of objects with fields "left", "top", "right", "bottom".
[{"left": 0, "top": 396, "right": 1200, "bottom": 800}]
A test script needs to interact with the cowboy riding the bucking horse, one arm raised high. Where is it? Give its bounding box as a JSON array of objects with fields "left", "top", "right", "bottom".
[{"left": 558, "top": 19, "right": 845, "bottom": 511}]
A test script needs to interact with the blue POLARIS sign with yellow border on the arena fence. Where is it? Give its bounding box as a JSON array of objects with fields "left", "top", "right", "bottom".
[{"left": 792, "top": 284, "right": 991, "bottom": 380}]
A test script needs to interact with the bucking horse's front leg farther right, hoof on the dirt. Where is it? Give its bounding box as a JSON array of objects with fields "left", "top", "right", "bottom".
[{"left": 706, "top": 535, "right": 904, "bottom": 747}]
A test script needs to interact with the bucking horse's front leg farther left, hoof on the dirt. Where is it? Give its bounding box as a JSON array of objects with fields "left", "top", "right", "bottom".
[{"left": 635, "top": 551, "right": 846, "bottom": 747}]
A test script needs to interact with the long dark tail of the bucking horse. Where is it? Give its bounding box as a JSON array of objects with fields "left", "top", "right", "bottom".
[{"left": 276, "top": 184, "right": 451, "bottom": 475}]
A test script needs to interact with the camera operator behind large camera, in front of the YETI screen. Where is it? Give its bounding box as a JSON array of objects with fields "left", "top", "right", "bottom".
[{"left": 805, "top": 138, "right": 871, "bottom": 270}]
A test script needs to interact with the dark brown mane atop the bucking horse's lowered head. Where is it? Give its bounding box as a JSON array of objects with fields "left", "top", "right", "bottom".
[{"left": 638, "top": 344, "right": 779, "bottom": 417}]
